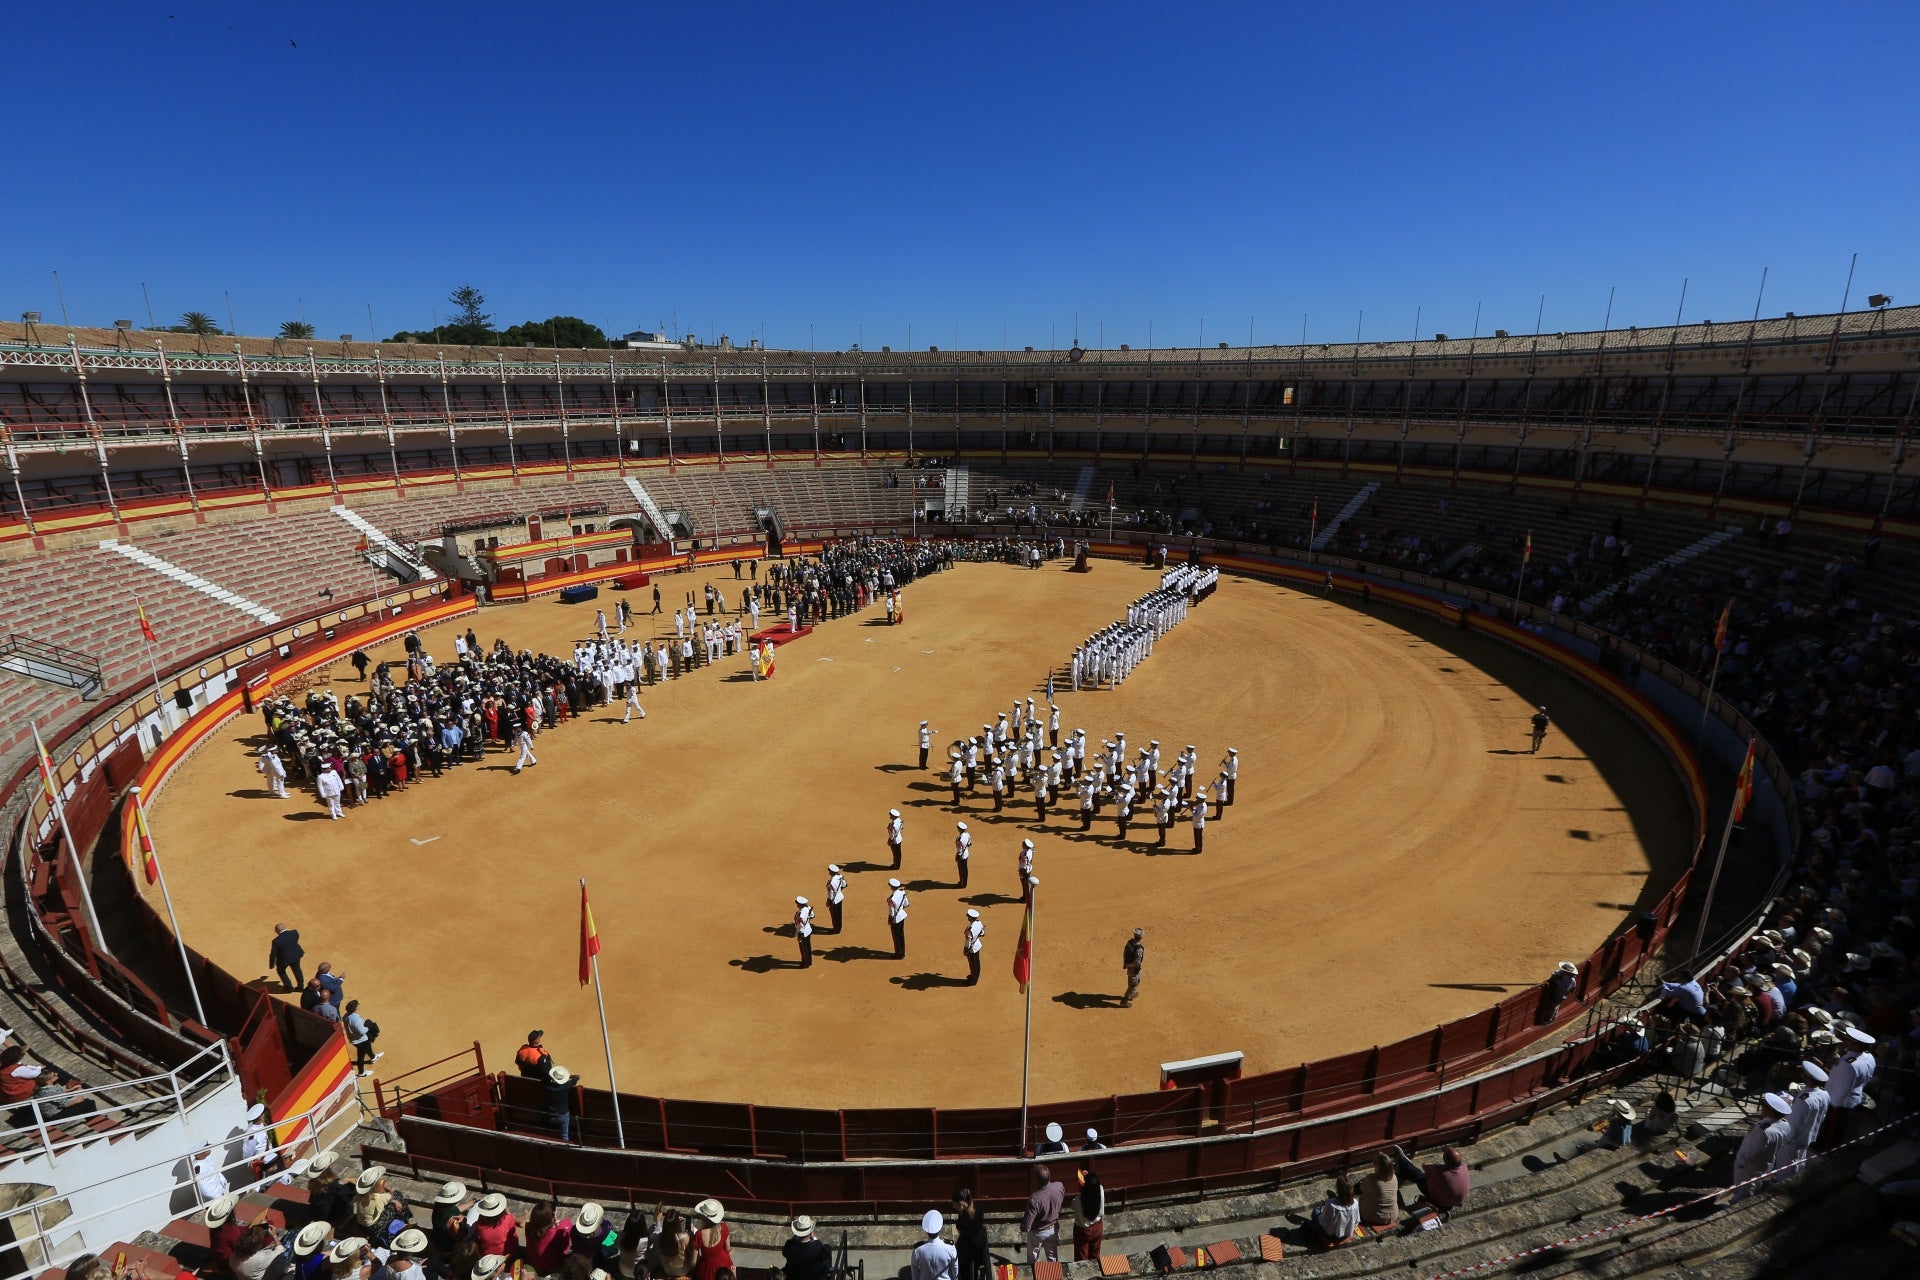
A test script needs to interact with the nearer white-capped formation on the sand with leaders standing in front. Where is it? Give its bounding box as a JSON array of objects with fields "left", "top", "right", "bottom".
[{"left": 793, "top": 699, "right": 1240, "bottom": 1004}]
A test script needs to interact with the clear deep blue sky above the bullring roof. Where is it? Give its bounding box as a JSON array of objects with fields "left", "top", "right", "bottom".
[{"left": 0, "top": 0, "right": 1920, "bottom": 349}]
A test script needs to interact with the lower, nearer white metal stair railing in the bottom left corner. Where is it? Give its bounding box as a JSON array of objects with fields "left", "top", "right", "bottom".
[{"left": 0, "top": 1075, "right": 359, "bottom": 1280}]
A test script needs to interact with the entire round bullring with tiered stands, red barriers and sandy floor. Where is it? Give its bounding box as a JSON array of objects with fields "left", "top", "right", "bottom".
[{"left": 0, "top": 309, "right": 1920, "bottom": 1280}]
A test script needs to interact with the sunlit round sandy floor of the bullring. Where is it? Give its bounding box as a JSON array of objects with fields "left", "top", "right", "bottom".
[{"left": 154, "top": 562, "right": 1688, "bottom": 1107}]
